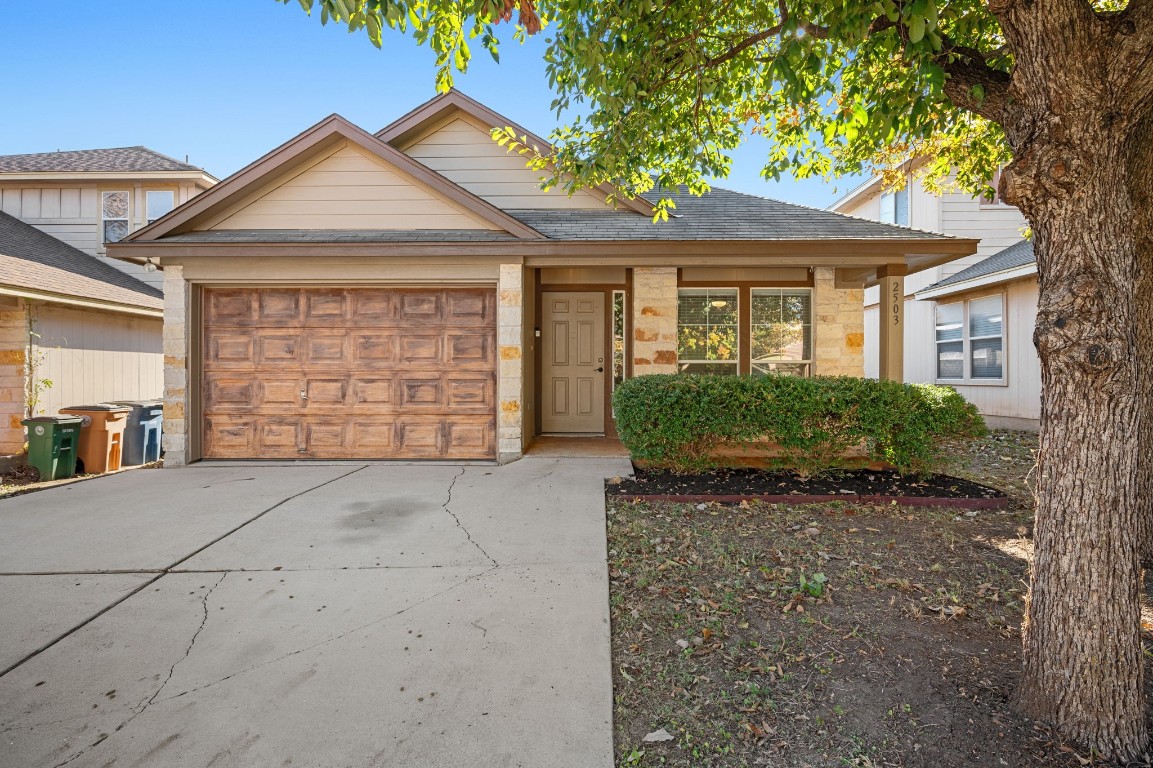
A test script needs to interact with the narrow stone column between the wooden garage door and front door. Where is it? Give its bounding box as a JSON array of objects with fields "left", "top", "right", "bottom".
[{"left": 497, "top": 264, "right": 525, "bottom": 462}]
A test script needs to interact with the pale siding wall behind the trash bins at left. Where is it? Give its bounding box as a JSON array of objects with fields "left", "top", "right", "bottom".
[{"left": 29, "top": 304, "right": 164, "bottom": 414}]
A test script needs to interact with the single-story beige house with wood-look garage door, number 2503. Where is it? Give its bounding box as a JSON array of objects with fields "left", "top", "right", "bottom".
[{"left": 110, "top": 91, "right": 975, "bottom": 466}]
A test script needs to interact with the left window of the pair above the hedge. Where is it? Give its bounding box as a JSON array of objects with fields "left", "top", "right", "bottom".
[{"left": 677, "top": 288, "right": 740, "bottom": 376}]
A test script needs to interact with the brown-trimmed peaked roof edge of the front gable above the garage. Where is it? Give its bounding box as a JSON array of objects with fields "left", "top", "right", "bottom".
[{"left": 125, "top": 114, "right": 542, "bottom": 242}]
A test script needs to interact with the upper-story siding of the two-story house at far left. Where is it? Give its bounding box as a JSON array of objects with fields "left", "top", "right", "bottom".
[{"left": 0, "top": 181, "right": 197, "bottom": 288}]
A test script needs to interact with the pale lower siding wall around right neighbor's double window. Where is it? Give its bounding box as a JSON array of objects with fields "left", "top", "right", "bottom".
[{"left": 865, "top": 279, "right": 1041, "bottom": 420}]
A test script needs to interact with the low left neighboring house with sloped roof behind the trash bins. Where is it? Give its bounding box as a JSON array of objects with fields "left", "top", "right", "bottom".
[{"left": 0, "top": 213, "right": 164, "bottom": 454}]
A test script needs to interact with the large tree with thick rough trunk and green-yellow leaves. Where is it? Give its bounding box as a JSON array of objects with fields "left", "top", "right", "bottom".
[{"left": 284, "top": 0, "right": 1153, "bottom": 759}]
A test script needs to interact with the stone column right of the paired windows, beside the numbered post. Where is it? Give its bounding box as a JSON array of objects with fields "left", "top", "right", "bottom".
[{"left": 813, "top": 266, "right": 865, "bottom": 376}]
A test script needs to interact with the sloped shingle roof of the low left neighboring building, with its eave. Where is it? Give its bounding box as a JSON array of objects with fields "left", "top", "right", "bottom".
[{"left": 0, "top": 212, "right": 164, "bottom": 309}]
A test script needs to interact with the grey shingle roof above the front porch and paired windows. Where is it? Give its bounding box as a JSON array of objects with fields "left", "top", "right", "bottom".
[{"left": 508, "top": 187, "right": 951, "bottom": 240}]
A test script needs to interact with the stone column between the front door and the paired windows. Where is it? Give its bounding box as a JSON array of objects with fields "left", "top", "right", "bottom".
[{"left": 632, "top": 266, "right": 677, "bottom": 376}]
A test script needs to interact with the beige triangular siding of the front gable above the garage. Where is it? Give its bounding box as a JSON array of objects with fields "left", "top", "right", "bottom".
[{"left": 208, "top": 144, "right": 497, "bottom": 229}]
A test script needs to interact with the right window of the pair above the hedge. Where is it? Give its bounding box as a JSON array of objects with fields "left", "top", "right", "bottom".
[{"left": 749, "top": 288, "right": 813, "bottom": 376}]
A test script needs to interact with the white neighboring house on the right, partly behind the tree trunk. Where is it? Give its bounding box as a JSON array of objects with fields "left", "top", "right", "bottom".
[{"left": 831, "top": 172, "right": 1041, "bottom": 429}]
